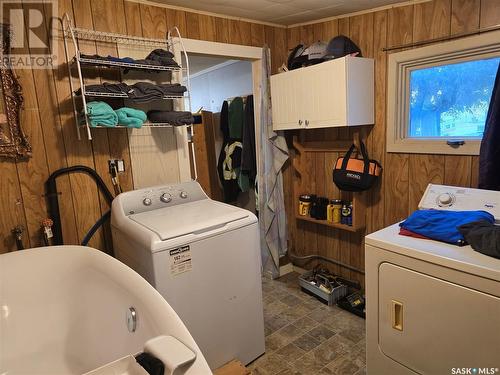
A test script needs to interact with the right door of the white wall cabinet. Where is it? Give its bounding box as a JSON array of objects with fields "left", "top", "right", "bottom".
[{"left": 305, "top": 59, "right": 347, "bottom": 128}]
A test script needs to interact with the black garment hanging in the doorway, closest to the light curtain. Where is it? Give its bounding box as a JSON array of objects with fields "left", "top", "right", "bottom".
[{"left": 241, "top": 95, "right": 257, "bottom": 181}]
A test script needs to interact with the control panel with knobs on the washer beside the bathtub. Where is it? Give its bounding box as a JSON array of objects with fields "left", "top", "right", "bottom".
[{"left": 117, "top": 181, "right": 209, "bottom": 215}]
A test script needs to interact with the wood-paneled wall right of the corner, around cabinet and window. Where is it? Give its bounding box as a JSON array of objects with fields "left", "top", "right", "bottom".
[{"left": 285, "top": 0, "right": 500, "bottom": 280}]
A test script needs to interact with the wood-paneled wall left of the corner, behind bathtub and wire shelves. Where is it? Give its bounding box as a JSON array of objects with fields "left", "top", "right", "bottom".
[{"left": 0, "top": 0, "right": 286, "bottom": 253}]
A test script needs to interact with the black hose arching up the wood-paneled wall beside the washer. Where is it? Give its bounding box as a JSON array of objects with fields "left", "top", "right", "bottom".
[{"left": 45, "top": 165, "right": 113, "bottom": 245}]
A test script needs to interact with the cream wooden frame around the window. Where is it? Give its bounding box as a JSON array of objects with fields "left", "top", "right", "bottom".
[{"left": 387, "top": 31, "right": 500, "bottom": 155}]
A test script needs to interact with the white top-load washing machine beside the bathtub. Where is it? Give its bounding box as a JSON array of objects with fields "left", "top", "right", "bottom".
[{"left": 111, "top": 181, "right": 265, "bottom": 369}]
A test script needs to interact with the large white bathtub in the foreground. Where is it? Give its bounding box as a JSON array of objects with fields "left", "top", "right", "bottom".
[{"left": 0, "top": 246, "right": 211, "bottom": 375}]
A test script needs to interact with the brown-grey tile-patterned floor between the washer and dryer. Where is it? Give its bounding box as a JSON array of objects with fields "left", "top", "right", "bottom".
[{"left": 248, "top": 273, "right": 366, "bottom": 375}]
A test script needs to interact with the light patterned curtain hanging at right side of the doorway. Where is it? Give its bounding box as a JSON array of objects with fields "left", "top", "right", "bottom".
[{"left": 258, "top": 46, "right": 288, "bottom": 278}]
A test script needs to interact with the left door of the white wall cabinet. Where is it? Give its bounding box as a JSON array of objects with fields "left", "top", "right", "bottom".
[{"left": 271, "top": 71, "right": 301, "bottom": 130}]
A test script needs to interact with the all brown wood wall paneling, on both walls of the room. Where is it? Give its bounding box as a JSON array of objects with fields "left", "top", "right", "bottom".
[{"left": 0, "top": 0, "right": 500, "bottom": 288}]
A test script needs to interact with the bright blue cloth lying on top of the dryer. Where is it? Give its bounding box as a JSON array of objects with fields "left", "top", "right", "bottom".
[{"left": 399, "top": 210, "right": 495, "bottom": 246}]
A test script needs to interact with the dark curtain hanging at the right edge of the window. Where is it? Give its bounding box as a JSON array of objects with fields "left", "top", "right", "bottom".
[{"left": 478, "top": 65, "right": 500, "bottom": 190}]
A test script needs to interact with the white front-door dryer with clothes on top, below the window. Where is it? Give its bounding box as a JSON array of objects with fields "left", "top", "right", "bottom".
[{"left": 365, "top": 185, "right": 500, "bottom": 375}]
